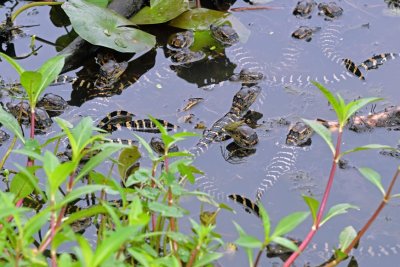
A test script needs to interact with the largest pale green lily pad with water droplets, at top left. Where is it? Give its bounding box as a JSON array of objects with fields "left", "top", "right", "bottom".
[{"left": 62, "top": 0, "right": 156, "bottom": 53}]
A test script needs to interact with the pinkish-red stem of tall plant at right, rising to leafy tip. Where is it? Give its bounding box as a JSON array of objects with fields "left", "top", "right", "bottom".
[{"left": 283, "top": 131, "right": 343, "bottom": 267}]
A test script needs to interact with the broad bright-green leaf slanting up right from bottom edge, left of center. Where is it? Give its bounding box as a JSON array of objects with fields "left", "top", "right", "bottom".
[{"left": 92, "top": 226, "right": 136, "bottom": 266}]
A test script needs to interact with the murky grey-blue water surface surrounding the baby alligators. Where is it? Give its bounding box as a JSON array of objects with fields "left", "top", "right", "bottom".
[{"left": 0, "top": 0, "right": 400, "bottom": 266}]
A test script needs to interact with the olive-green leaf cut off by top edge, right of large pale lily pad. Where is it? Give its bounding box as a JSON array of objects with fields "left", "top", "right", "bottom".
[{"left": 130, "top": 0, "right": 188, "bottom": 24}]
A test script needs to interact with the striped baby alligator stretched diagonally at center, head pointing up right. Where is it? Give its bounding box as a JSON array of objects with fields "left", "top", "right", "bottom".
[{"left": 189, "top": 84, "right": 261, "bottom": 156}]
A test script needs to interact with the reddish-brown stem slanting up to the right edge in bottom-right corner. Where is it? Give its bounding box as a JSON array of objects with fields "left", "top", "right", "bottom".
[{"left": 324, "top": 167, "right": 400, "bottom": 267}]
